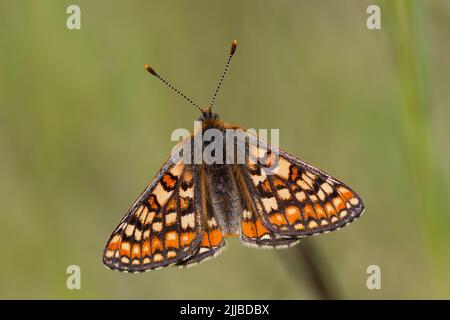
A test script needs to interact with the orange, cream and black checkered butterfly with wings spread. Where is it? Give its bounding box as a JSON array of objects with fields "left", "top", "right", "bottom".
[{"left": 103, "top": 41, "right": 364, "bottom": 272}]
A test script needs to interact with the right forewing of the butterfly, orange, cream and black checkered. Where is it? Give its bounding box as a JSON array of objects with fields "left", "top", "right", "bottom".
[{"left": 240, "top": 139, "right": 364, "bottom": 238}]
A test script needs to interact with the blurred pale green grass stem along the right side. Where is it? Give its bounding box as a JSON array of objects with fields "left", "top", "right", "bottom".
[{"left": 387, "top": 0, "right": 450, "bottom": 298}]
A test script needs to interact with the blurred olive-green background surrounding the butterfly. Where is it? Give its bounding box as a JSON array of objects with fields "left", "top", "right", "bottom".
[{"left": 0, "top": 0, "right": 450, "bottom": 299}]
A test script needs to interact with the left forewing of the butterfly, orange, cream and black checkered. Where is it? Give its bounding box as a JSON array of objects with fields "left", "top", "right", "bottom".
[{"left": 103, "top": 160, "right": 203, "bottom": 272}]
